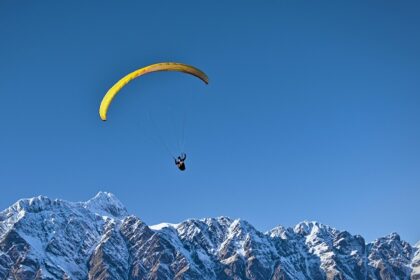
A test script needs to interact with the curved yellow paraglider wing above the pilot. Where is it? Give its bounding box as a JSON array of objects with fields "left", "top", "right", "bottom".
[{"left": 99, "top": 62, "right": 209, "bottom": 121}]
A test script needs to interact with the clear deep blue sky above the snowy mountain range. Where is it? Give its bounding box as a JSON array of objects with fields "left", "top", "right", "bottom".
[{"left": 0, "top": 0, "right": 420, "bottom": 243}]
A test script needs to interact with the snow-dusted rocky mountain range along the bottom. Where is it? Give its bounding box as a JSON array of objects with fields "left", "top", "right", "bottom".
[{"left": 0, "top": 192, "right": 420, "bottom": 280}]
